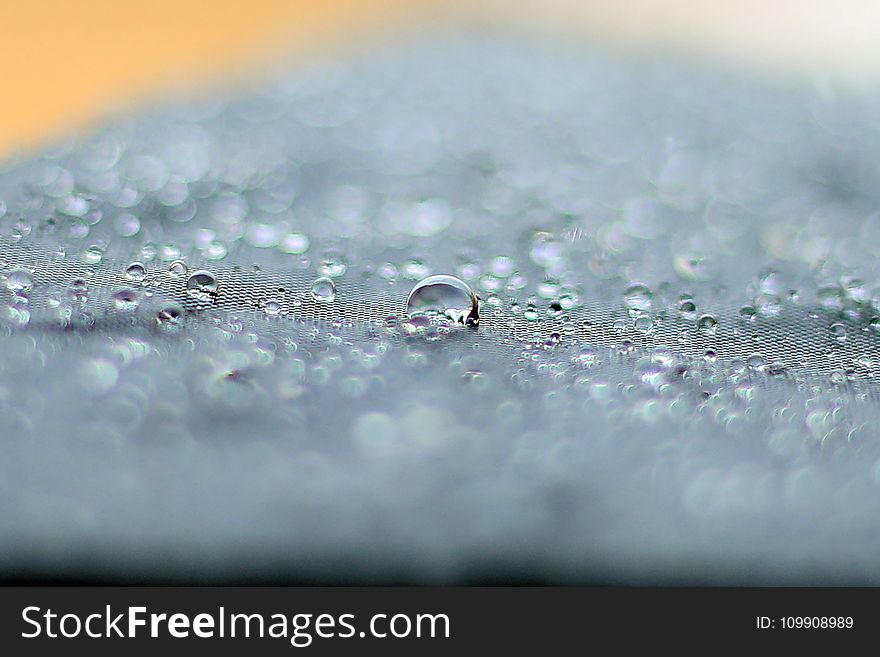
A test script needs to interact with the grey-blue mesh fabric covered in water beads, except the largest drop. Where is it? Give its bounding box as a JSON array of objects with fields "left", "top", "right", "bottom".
[{"left": 0, "top": 36, "right": 880, "bottom": 583}]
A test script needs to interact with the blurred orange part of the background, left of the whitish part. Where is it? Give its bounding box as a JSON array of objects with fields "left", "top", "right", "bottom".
[{"left": 0, "top": 0, "right": 419, "bottom": 155}]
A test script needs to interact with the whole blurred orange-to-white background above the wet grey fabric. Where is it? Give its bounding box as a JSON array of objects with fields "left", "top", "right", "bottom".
[{"left": 0, "top": 0, "right": 880, "bottom": 154}]
